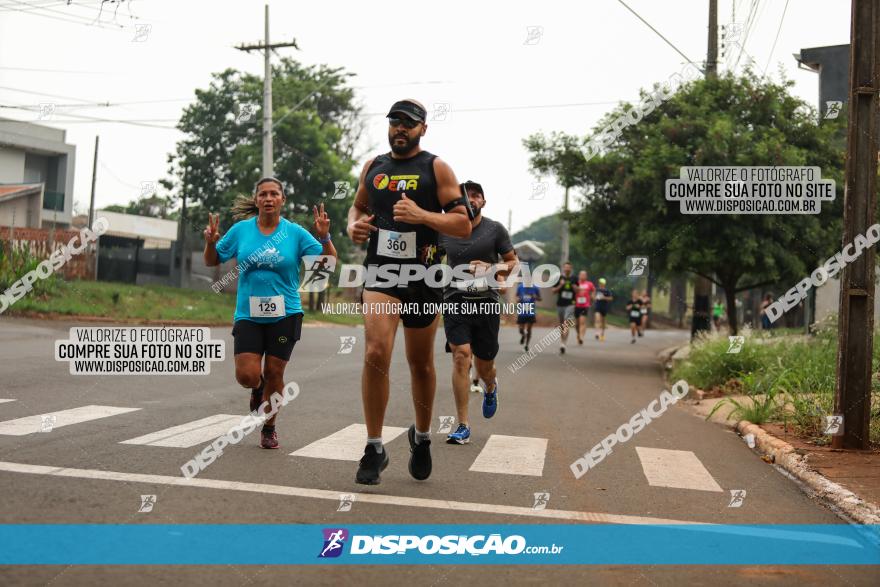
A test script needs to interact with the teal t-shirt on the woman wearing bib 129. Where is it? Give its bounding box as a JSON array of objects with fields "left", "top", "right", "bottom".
[{"left": 217, "top": 216, "right": 323, "bottom": 323}]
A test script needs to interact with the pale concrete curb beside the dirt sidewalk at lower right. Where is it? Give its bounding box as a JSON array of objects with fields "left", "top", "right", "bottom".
[{"left": 735, "top": 420, "right": 880, "bottom": 524}]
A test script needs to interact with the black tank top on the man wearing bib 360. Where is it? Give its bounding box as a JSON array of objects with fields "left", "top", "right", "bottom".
[{"left": 365, "top": 151, "right": 442, "bottom": 265}]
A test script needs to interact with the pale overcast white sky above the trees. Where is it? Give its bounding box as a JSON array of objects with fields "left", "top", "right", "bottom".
[{"left": 0, "top": 0, "right": 850, "bottom": 230}]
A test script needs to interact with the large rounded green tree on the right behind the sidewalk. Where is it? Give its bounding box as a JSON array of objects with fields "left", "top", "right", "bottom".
[{"left": 525, "top": 71, "right": 844, "bottom": 333}]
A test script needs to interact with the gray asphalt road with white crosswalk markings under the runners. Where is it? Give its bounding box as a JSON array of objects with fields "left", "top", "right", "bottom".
[{"left": 0, "top": 317, "right": 880, "bottom": 585}]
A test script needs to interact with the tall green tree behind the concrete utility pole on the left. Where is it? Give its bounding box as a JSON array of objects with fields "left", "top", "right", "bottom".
[{"left": 162, "top": 59, "right": 363, "bottom": 262}]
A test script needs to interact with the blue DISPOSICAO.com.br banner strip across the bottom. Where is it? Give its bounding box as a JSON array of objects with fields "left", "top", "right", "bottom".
[{"left": 0, "top": 524, "right": 880, "bottom": 565}]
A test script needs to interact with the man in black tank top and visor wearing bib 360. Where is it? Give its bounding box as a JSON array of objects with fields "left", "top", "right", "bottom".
[{"left": 348, "top": 100, "right": 471, "bottom": 485}]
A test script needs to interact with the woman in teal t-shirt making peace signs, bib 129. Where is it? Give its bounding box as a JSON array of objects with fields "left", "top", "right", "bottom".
[{"left": 204, "top": 177, "right": 336, "bottom": 448}]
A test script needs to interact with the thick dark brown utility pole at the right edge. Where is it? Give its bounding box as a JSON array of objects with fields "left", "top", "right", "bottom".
[{"left": 831, "top": 0, "right": 880, "bottom": 449}]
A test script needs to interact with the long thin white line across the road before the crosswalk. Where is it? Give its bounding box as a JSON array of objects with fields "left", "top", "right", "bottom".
[{"left": 0, "top": 461, "right": 710, "bottom": 526}]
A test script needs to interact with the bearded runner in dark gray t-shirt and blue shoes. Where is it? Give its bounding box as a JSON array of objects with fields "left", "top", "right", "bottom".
[{"left": 440, "top": 181, "right": 517, "bottom": 444}]
